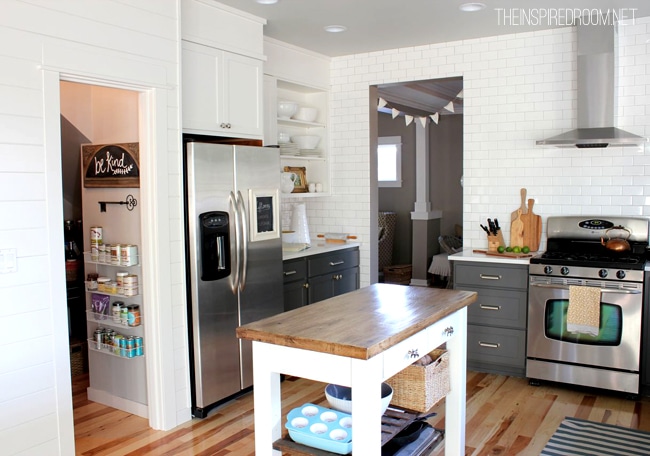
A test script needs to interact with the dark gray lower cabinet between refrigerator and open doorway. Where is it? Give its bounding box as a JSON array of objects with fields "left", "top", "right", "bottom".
[{"left": 284, "top": 247, "right": 359, "bottom": 311}]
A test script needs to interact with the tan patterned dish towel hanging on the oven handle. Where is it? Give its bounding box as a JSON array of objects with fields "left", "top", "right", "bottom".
[{"left": 566, "top": 285, "right": 600, "bottom": 336}]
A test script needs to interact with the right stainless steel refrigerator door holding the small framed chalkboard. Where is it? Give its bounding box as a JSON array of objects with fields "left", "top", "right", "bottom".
[{"left": 235, "top": 146, "right": 284, "bottom": 388}]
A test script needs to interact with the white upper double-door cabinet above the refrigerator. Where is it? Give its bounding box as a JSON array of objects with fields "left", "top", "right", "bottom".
[{"left": 181, "top": 0, "right": 266, "bottom": 139}]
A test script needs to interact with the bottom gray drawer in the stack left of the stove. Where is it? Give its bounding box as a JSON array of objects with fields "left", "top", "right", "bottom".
[{"left": 467, "top": 325, "right": 526, "bottom": 368}]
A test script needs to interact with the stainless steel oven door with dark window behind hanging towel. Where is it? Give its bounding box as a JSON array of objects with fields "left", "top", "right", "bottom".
[{"left": 527, "top": 276, "right": 643, "bottom": 372}]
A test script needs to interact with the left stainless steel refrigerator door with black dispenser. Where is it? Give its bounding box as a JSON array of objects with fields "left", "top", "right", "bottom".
[{"left": 186, "top": 143, "right": 241, "bottom": 409}]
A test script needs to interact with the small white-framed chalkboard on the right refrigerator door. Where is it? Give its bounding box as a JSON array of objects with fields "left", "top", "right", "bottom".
[{"left": 248, "top": 189, "right": 280, "bottom": 242}]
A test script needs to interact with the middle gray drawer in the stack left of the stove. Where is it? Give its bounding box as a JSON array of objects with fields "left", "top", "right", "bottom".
[{"left": 463, "top": 287, "right": 528, "bottom": 329}]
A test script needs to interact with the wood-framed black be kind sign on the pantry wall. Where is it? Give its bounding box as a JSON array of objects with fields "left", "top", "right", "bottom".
[{"left": 81, "top": 143, "right": 140, "bottom": 188}]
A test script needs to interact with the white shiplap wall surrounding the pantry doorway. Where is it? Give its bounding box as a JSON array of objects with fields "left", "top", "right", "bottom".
[{"left": 0, "top": 0, "right": 190, "bottom": 456}]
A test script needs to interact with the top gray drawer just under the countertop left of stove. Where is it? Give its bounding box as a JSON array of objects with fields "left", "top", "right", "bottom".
[{"left": 454, "top": 261, "right": 528, "bottom": 290}]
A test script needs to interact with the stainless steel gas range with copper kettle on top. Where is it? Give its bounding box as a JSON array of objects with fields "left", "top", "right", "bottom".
[{"left": 526, "top": 216, "right": 649, "bottom": 394}]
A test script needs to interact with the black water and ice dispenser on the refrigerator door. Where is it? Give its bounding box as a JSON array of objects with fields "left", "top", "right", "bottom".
[{"left": 199, "top": 211, "right": 230, "bottom": 281}]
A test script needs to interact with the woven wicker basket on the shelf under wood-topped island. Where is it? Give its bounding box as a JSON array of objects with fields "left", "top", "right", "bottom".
[{"left": 387, "top": 349, "right": 449, "bottom": 412}]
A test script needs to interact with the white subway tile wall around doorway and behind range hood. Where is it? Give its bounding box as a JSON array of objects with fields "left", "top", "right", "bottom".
[{"left": 318, "top": 18, "right": 650, "bottom": 285}]
